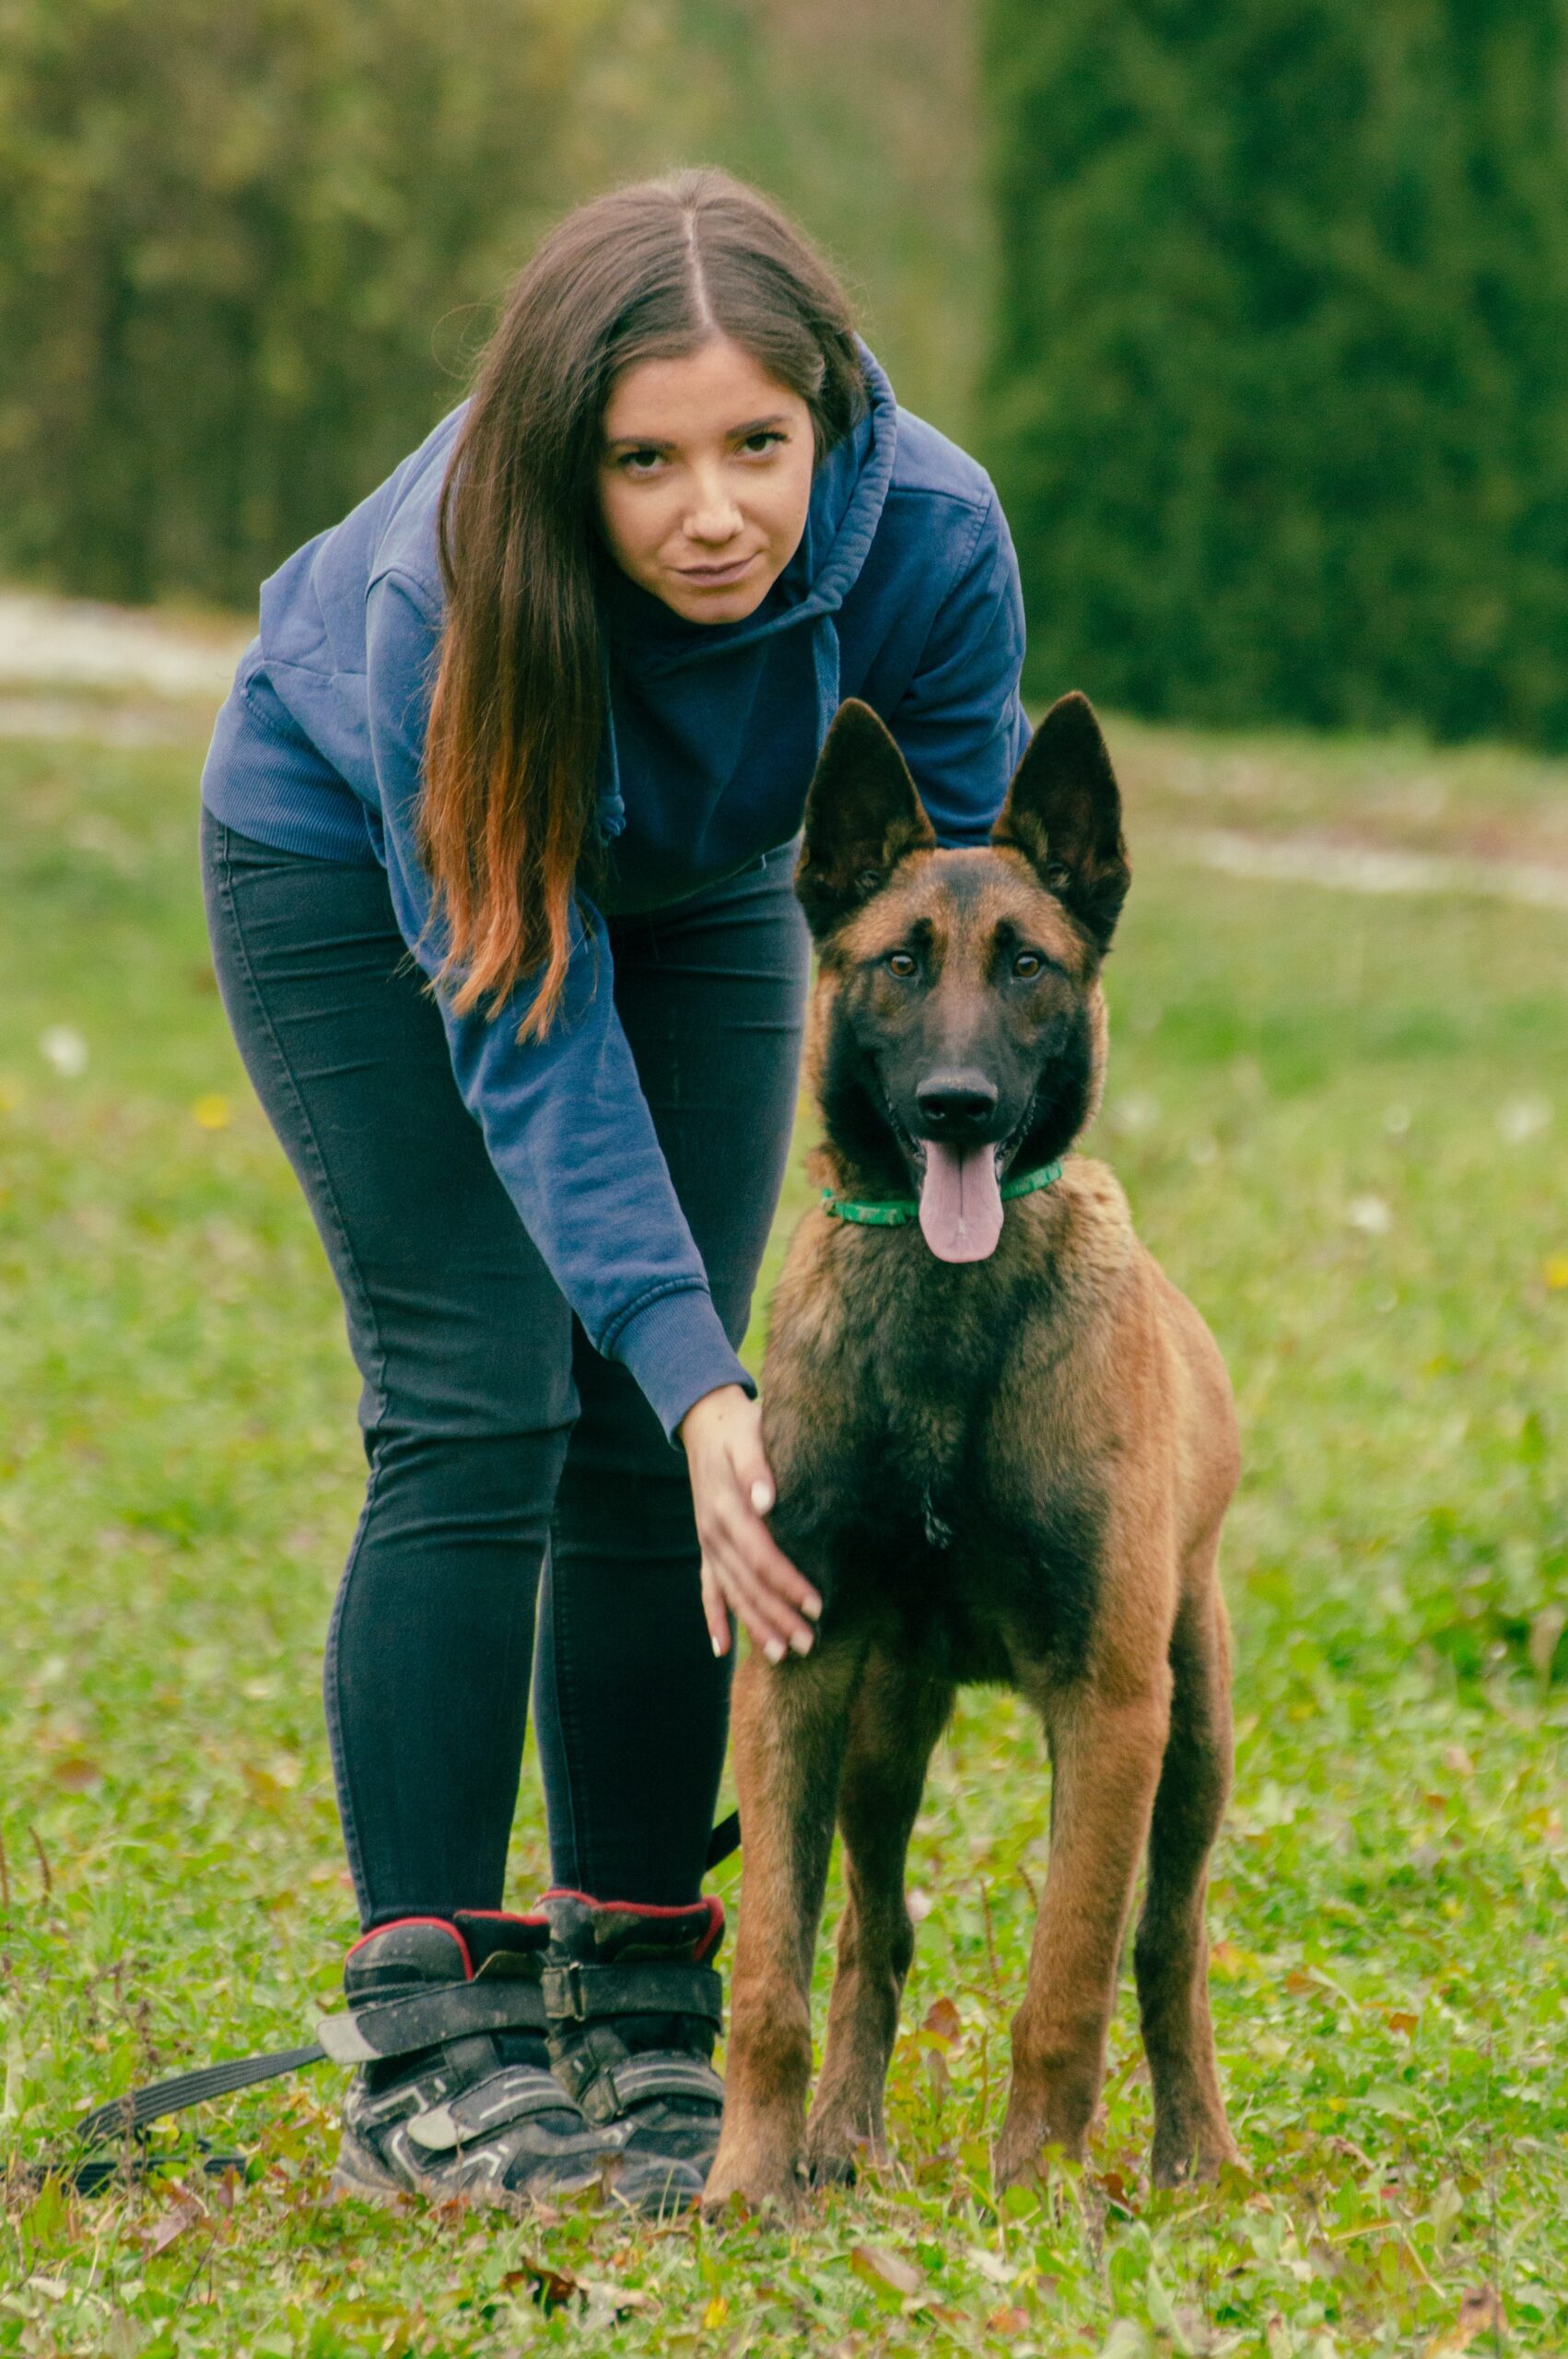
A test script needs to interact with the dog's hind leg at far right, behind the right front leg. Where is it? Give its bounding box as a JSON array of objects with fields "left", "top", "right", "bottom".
[{"left": 1134, "top": 1568, "right": 1235, "bottom": 2187}]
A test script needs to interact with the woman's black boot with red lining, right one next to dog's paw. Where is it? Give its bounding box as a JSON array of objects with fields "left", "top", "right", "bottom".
[{"left": 540, "top": 1892, "right": 724, "bottom": 2212}]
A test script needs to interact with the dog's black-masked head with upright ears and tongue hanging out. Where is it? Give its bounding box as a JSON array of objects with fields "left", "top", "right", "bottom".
[{"left": 795, "top": 696, "right": 1129, "bottom": 1260}]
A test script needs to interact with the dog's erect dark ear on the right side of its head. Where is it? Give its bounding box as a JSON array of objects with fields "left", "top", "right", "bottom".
[{"left": 990, "top": 691, "right": 1132, "bottom": 953}]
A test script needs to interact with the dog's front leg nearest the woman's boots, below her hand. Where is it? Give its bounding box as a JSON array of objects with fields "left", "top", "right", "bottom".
[{"left": 703, "top": 1637, "right": 863, "bottom": 2215}]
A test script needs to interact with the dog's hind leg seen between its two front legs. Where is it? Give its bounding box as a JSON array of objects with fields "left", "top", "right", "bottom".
[{"left": 806, "top": 1651, "right": 953, "bottom": 2182}]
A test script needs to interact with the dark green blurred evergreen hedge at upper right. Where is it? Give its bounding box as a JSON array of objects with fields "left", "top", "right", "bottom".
[{"left": 981, "top": 0, "right": 1568, "bottom": 745}]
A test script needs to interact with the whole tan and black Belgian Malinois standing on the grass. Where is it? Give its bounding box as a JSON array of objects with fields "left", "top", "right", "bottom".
[{"left": 705, "top": 696, "right": 1238, "bottom": 2212}]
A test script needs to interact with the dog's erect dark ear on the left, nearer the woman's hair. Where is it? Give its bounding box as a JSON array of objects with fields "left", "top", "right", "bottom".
[{"left": 795, "top": 696, "right": 936, "bottom": 934}]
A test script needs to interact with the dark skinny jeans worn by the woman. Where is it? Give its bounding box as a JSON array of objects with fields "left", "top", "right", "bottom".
[{"left": 203, "top": 814, "right": 806, "bottom": 1928}]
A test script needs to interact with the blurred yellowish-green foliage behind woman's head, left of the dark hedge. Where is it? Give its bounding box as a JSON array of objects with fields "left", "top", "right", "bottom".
[{"left": 0, "top": 0, "right": 978, "bottom": 604}]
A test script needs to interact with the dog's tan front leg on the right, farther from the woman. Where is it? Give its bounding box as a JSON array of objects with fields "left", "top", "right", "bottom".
[{"left": 995, "top": 1672, "right": 1169, "bottom": 2189}]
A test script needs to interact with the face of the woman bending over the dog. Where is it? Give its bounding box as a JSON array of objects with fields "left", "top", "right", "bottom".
[{"left": 599, "top": 337, "right": 816, "bottom": 623}]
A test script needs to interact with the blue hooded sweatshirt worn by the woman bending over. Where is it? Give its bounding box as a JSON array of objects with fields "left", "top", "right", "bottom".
[{"left": 203, "top": 346, "right": 1028, "bottom": 1434}]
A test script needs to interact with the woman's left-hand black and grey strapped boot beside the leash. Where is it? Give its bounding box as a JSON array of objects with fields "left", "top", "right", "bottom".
[{"left": 319, "top": 1908, "right": 627, "bottom": 2212}]
